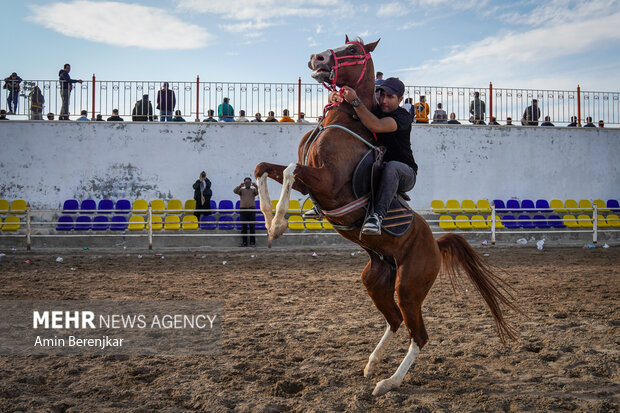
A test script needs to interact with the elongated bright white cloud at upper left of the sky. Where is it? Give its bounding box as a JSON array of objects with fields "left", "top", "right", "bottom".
[{"left": 28, "top": 0, "right": 212, "bottom": 50}]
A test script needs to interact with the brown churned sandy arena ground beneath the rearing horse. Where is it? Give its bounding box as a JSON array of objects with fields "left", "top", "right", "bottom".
[{"left": 0, "top": 247, "right": 620, "bottom": 412}]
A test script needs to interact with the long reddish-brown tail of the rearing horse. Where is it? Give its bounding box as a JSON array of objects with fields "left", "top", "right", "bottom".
[{"left": 437, "top": 234, "right": 521, "bottom": 344}]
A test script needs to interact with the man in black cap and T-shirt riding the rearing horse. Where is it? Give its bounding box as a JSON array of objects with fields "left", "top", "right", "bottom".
[{"left": 330, "top": 77, "right": 418, "bottom": 235}]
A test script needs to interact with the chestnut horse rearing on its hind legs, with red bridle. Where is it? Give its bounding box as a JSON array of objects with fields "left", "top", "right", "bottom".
[{"left": 254, "top": 37, "right": 516, "bottom": 396}]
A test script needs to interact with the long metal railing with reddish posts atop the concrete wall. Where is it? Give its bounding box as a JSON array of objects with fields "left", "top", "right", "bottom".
[{"left": 0, "top": 75, "right": 620, "bottom": 125}]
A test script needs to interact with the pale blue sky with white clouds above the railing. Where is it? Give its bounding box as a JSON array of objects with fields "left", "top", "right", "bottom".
[{"left": 0, "top": 0, "right": 620, "bottom": 91}]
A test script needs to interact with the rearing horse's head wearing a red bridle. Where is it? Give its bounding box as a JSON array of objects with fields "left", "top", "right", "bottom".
[{"left": 308, "top": 36, "right": 379, "bottom": 88}]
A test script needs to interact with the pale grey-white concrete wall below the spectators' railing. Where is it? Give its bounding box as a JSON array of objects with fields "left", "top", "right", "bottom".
[{"left": 0, "top": 121, "right": 620, "bottom": 208}]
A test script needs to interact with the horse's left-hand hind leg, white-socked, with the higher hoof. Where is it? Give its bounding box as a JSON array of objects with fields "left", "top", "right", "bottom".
[{"left": 362, "top": 251, "right": 403, "bottom": 377}]
